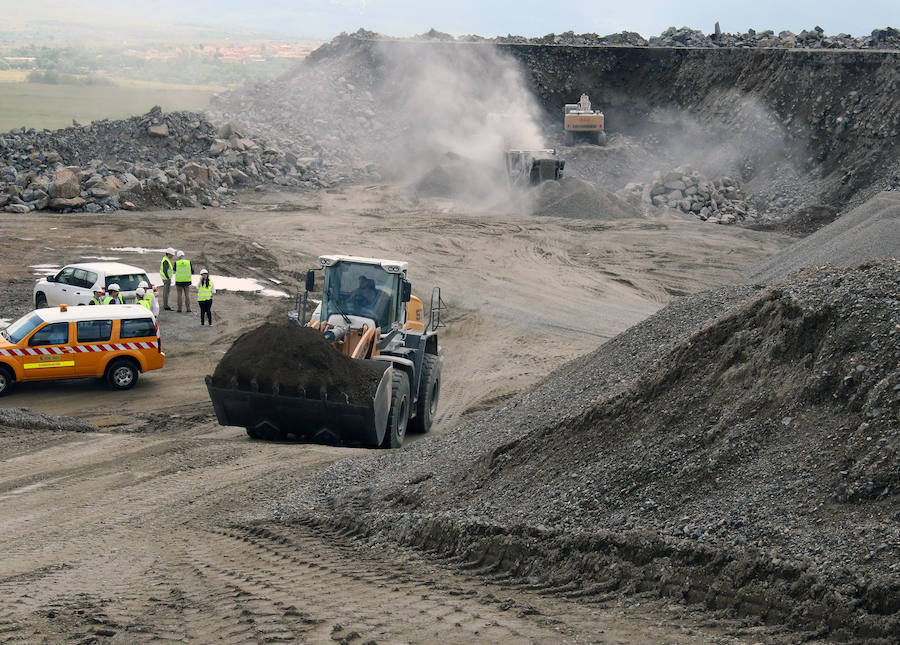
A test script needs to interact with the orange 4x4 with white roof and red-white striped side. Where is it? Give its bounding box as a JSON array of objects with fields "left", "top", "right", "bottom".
[{"left": 0, "top": 305, "right": 166, "bottom": 396}]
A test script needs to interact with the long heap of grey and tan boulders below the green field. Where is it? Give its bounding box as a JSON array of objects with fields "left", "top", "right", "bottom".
[{"left": 0, "top": 107, "right": 317, "bottom": 213}]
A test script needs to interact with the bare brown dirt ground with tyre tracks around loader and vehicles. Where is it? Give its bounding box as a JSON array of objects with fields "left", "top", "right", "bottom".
[{"left": 0, "top": 186, "right": 789, "bottom": 643}]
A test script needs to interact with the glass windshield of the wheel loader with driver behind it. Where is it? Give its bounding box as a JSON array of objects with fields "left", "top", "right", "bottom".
[{"left": 322, "top": 262, "right": 400, "bottom": 329}]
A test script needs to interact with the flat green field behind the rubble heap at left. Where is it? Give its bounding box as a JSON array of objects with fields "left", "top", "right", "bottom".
[{"left": 0, "top": 82, "right": 215, "bottom": 132}]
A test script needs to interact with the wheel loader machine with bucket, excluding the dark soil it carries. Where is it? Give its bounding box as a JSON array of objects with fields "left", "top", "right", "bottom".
[{"left": 206, "top": 255, "right": 444, "bottom": 448}]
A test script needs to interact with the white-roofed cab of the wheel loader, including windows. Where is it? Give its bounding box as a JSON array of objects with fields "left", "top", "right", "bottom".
[{"left": 319, "top": 256, "right": 409, "bottom": 332}]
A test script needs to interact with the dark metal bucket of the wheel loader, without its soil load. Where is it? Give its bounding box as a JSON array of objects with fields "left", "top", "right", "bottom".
[{"left": 206, "top": 360, "right": 393, "bottom": 446}]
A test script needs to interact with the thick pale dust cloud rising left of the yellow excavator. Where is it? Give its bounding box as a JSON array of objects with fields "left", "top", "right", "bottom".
[{"left": 368, "top": 44, "right": 544, "bottom": 205}]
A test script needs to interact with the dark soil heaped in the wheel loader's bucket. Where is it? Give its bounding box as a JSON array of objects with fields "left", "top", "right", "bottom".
[{"left": 212, "top": 323, "right": 382, "bottom": 405}]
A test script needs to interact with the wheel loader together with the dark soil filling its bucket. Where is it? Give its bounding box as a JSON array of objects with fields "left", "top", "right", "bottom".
[{"left": 206, "top": 255, "right": 444, "bottom": 448}]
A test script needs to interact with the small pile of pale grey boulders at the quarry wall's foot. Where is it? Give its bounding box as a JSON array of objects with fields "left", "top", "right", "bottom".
[{"left": 622, "top": 166, "right": 759, "bottom": 224}]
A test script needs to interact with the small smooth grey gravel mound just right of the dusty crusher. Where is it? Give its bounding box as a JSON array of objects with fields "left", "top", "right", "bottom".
[{"left": 534, "top": 177, "right": 641, "bottom": 219}]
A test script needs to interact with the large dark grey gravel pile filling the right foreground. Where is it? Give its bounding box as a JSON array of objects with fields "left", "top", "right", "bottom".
[{"left": 276, "top": 261, "right": 900, "bottom": 642}]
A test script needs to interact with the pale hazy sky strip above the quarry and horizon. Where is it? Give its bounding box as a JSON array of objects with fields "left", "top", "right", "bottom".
[{"left": 8, "top": 0, "right": 900, "bottom": 40}]
